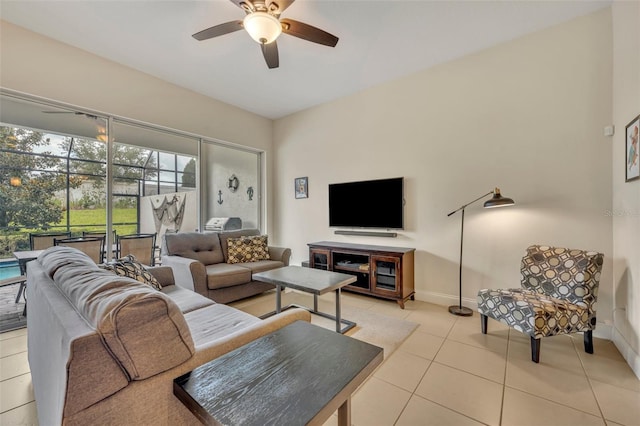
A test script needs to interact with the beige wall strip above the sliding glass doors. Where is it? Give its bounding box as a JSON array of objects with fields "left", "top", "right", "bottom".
[{"left": 0, "top": 21, "right": 272, "bottom": 233}]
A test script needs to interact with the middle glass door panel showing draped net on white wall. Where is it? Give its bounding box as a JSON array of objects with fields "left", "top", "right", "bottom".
[{"left": 112, "top": 120, "right": 199, "bottom": 244}]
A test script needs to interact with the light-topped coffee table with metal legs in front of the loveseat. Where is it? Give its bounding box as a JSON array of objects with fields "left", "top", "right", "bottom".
[{"left": 253, "top": 266, "right": 357, "bottom": 334}]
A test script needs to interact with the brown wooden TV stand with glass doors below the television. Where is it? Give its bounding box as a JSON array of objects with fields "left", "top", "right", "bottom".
[{"left": 307, "top": 241, "right": 416, "bottom": 309}]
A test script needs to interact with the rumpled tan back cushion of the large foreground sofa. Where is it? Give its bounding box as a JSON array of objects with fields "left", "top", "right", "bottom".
[{"left": 38, "top": 246, "right": 195, "bottom": 380}]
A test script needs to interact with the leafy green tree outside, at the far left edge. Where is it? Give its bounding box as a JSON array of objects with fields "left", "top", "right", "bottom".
[{"left": 0, "top": 126, "right": 80, "bottom": 230}]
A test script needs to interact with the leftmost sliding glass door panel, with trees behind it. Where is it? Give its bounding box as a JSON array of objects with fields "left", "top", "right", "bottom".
[{"left": 0, "top": 96, "right": 107, "bottom": 259}]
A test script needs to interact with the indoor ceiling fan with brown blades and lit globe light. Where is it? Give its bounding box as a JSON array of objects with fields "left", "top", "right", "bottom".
[{"left": 193, "top": 0, "right": 338, "bottom": 68}]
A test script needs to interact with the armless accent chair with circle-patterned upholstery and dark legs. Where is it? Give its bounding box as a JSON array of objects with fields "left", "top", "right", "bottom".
[{"left": 478, "top": 245, "right": 604, "bottom": 362}]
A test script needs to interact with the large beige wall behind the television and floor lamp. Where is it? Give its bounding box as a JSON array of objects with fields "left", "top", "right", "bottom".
[{"left": 274, "top": 9, "right": 613, "bottom": 334}]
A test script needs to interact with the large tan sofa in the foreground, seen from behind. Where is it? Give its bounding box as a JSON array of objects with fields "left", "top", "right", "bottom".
[{"left": 27, "top": 247, "right": 310, "bottom": 425}]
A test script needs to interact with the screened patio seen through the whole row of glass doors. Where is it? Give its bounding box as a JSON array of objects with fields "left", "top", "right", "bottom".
[{"left": 0, "top": 90, "right": 262, "bottom": 259}]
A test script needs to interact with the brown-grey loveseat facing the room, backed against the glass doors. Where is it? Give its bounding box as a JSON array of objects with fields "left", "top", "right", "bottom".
[{"left": 162, "top": 229, "right": 291, "bottom": 303}]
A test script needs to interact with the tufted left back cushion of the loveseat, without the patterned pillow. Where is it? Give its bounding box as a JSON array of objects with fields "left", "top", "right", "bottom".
[{"left": 164, "top": 232, "right": 225, "bottom": 265}]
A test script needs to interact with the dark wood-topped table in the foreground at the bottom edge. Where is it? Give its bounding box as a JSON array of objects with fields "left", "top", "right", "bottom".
[{"left": 173, "top": 321, "right": 383, "bottom": 426}]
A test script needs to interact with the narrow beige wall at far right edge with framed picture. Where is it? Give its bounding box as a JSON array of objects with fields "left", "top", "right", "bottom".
[{"left": 612, "top": 2, "right": 640, "bottom": 377}]
